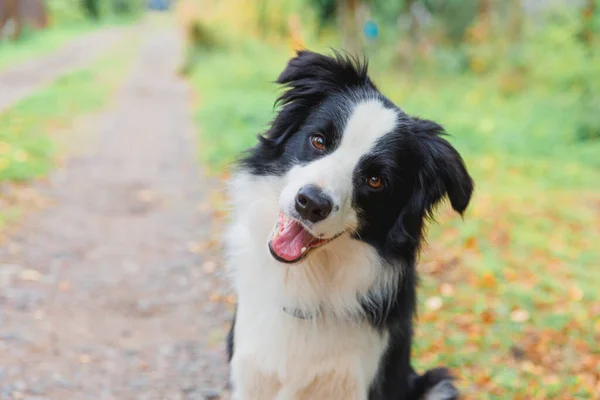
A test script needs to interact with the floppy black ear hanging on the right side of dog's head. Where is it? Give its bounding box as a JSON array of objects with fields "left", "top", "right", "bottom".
[{"left": 414, "top": 119, "right": 473, "bottom": 214}]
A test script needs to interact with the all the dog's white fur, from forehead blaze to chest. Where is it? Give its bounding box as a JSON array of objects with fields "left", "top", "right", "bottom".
[{"left": 226, "top": 101, "right": 396, "bottom": 400}]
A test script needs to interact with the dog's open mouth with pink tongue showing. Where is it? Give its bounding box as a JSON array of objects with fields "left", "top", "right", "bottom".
[{"left": 269, "top": 212, "right": 339, "bottom": 264}]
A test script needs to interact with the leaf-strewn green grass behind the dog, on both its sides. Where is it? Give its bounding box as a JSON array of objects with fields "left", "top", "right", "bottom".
[{"left": 190, "top": 33, "right": 600, "bottom": 399}]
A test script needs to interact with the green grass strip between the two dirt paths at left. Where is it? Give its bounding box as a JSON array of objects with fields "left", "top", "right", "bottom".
[{"left": 0, "top": 36, "right": 137, "bottom": 228}]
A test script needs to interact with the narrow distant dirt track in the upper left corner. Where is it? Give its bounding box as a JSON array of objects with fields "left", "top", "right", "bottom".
[{"left": 0, "top": 27, "right": 128, "bottom": 112}]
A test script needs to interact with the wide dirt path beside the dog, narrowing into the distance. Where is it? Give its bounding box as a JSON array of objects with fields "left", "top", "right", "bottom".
[{"left": 0, "top": 31, "right": 230, "bottom": 400}]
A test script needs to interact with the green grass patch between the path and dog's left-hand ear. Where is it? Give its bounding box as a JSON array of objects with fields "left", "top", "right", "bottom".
[{"left": 190, "top": 43, "right": 286, "bottom": 172}]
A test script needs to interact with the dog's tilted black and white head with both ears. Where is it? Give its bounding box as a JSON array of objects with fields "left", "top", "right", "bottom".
[{"left": 243, "top": 51, "right": 473, "bottom": 263}]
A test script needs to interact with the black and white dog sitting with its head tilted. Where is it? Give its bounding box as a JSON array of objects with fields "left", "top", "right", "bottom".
[{"left": 226, "top": 51, "right": 473, "bottom": 400}]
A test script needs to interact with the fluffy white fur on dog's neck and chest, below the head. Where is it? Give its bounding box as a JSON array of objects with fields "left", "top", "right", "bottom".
[{"left": 226, "top": 175, "right": 393, "bottom": 400}]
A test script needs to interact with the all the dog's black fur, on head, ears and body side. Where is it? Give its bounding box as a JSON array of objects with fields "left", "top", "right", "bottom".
[{"left": 229, "top": 51, "right": 473, "bottom": 400}]
